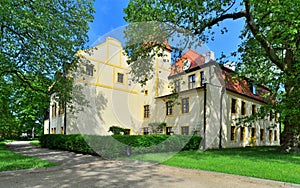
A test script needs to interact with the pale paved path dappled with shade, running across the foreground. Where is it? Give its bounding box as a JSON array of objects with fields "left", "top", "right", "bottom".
[{"left": 0, "top": 142, "right": 300, "bottom": 188}]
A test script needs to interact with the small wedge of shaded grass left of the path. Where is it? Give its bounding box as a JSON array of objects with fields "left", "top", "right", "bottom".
[{"left": 0, "top": 142, "right": 57, "bottom": 172}]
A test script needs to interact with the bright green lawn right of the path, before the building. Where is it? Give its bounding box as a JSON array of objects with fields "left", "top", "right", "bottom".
[{"left": 126, "top": 147, "right": 300, "bottom": 184}]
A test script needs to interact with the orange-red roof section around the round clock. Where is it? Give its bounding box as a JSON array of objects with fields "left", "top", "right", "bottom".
[{"left": 169, "top": 49, "right": 205, "bottom": 77}]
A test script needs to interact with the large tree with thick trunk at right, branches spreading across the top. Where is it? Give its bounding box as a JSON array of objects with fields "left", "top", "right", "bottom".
[{"left": 124, "top": 0, "right": 300, "bottom": 151}]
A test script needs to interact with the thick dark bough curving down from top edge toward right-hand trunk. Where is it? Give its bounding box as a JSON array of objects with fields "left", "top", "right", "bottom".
[{"left": 245, "top": 0, "right": 285, "bottom": 71}]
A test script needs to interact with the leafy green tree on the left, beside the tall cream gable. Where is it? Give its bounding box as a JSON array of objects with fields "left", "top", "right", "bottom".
[{"left": 0, "top": 0, "right": 94, "bottom": 138}]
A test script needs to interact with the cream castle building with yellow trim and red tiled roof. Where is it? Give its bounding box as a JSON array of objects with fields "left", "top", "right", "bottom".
[{"left": 44, "top": 38, "right": 280, "bottom": 149}]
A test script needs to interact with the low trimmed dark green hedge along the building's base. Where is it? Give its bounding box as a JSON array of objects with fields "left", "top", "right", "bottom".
[{"left": 40, "top": 134, "right": 201, "bottom": 158}]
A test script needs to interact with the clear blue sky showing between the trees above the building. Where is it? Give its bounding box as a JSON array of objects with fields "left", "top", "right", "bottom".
[{"left": 87, "top": 0, "right": 243, "bottom": 61}]
